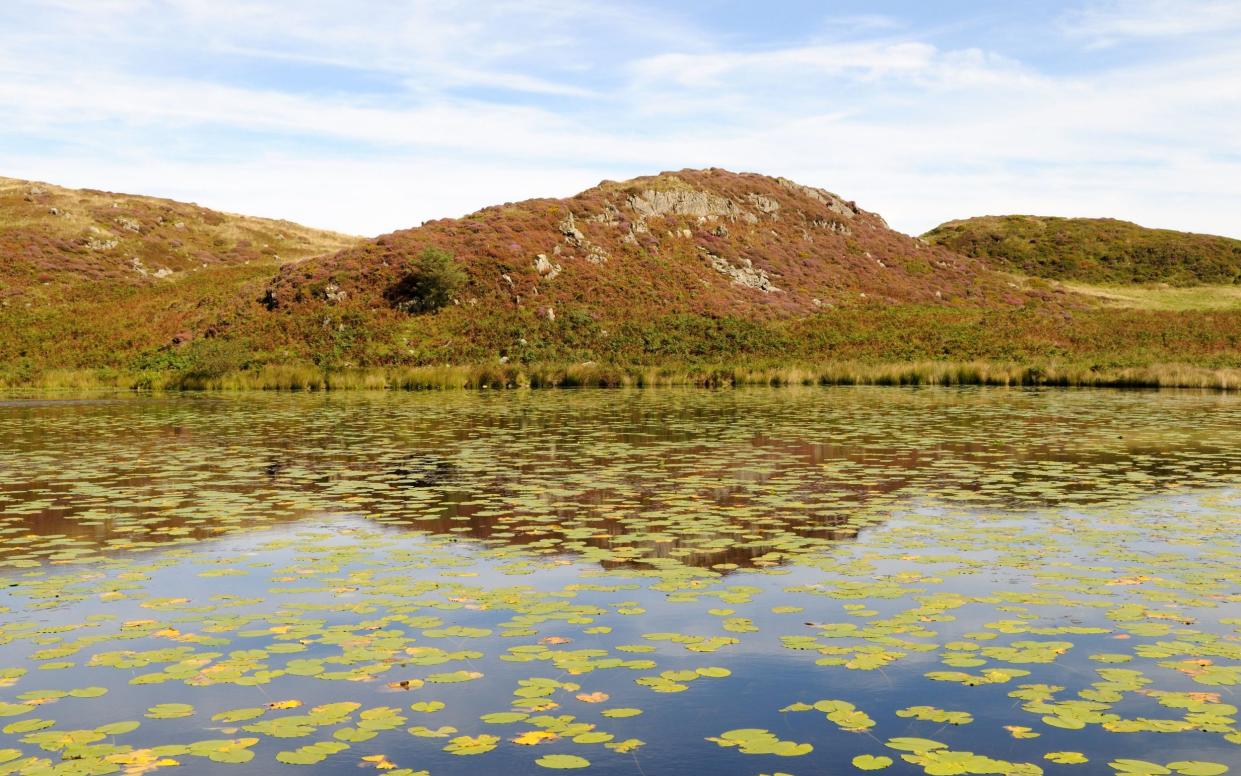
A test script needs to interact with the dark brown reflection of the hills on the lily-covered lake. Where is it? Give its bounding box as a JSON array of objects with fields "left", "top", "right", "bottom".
[{"left": 0, "top": 389, "right": 1241, "bottom": 566}]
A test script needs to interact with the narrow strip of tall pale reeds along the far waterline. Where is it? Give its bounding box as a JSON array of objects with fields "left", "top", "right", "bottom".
[{"left": 9, "top": 361, "right": 1241, "bottom": 391}]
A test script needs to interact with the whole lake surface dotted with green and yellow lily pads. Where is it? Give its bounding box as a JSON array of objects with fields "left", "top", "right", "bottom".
[{"left": 0, "top": 387, "right": 1241, "bottom": 776}]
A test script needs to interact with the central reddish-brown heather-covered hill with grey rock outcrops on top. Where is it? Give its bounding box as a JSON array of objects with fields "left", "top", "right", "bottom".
[{"left": 268, "top": 169, "right": 1042, "bottom": 319}]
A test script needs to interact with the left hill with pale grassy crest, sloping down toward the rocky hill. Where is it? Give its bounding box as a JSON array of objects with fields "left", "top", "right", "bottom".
[{"left": 0, "top": 178, "right": 357, "bottom": 379}]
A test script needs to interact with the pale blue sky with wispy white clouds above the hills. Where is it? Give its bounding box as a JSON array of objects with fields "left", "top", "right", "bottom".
[{"left": 0, "top": 0, "right": 1241, "bottom": 237}]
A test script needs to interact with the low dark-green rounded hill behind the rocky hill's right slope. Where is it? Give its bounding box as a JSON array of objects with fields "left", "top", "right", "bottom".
[{"left": 923, "top": 216, "right": 1241, "bottom": 286}]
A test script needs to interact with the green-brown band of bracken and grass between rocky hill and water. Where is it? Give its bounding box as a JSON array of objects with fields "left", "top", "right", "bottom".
[{"left": 7, "top": 299, "right": 1241, "bottom": 390}]
